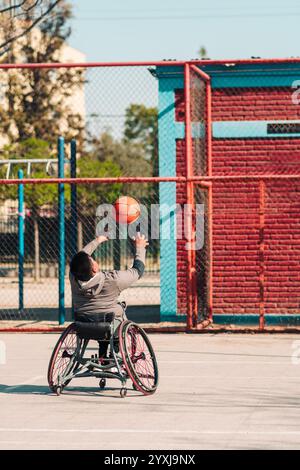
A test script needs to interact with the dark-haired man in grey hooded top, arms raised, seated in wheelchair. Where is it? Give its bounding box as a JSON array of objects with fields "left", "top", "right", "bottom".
[{"left": 69, "top": 233, "right": 148, "bottom": 360}]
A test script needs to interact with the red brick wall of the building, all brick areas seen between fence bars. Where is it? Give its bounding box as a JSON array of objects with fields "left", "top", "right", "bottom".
[{"left": 176, "top": 88, "right": 300, "bottom": 314}]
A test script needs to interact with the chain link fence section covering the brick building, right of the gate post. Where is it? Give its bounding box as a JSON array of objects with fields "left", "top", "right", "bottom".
[{"left": 212, "top": 61, "right": 300, "bottom": 328}]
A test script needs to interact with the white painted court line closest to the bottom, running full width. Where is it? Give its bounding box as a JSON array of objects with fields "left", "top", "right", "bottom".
[{"left": 0, "top": 428, "right": 300, "bottom": 436}]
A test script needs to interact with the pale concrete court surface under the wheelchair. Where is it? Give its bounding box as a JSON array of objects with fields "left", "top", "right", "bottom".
[{"left": 0, "top": 333, "right": 300, "bottom": 450}]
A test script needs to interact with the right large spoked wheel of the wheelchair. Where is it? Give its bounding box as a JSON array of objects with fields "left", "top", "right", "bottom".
[{"left": 119, "top": 321, "right": 158, "bottom": 395}]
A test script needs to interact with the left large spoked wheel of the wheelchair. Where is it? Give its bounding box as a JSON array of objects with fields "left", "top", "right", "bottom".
[{"left": 48, "top": 323, "right": 78, "bottom": 392}]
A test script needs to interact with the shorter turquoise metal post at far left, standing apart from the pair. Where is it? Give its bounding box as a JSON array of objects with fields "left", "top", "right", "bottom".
[{"left": 18, "top": 170, "right": 24, "bottom": 312}]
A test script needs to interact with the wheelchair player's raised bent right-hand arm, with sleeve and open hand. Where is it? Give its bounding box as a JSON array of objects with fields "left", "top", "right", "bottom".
[{"left": 116, "top": 234, "right": 148, "bottom": 291}]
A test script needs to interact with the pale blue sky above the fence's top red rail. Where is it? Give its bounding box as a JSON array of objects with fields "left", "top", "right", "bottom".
[{"left": 69, "top": 0, "right": 300, "bottom": 61}]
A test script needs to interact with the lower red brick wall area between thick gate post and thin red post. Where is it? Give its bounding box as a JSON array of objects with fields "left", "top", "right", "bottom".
[{"left": 213, "top": 182, "right": 259, "bottom": 314}]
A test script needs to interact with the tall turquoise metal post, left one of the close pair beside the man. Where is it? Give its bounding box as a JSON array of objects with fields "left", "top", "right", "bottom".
[{"left": 57, "top": 137, "right": 65, "bottom": 325}]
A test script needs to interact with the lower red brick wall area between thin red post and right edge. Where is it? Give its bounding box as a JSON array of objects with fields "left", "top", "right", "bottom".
[{"left": 265, "top": 182, "right": 300, "bottom": 314}]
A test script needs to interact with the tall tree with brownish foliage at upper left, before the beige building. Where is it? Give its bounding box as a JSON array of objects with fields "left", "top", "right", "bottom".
[{"left": 0, "top": 0, "right": 85, "bottom": 148}]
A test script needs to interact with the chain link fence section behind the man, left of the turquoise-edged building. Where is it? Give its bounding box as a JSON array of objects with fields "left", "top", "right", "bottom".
[{"left": 0, "top": 66, "right": 164, "bottom": 321}]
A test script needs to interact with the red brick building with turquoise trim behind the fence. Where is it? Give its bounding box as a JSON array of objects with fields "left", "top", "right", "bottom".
[{"left": 156, "top": 61, "right": 300, "bottom": 322}]
